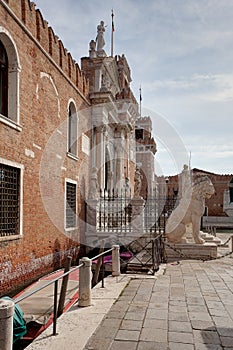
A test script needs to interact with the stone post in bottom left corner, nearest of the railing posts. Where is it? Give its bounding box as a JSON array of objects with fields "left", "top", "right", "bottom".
[{"left": 0, "top": 299, "right": 14, "bottom": 350}]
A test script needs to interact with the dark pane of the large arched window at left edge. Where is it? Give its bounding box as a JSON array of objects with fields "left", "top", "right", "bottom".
[{"left": 0, "top": 40, "right": 8, "bottom": 117}]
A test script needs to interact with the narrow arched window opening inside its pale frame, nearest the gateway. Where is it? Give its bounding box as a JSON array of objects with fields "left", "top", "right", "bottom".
[{"left": 68, "top": 102, "right": 78, "bottom": 157}]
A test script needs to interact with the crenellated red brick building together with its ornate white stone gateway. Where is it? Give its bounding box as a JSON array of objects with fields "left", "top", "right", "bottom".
[{"left": 0, "top": 0, "right": 144, "bottom": 295}]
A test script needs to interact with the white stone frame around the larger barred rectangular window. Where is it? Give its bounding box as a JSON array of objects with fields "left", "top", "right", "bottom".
[{"left": 0, "top": 157, "right": 24, "bottom": 242}]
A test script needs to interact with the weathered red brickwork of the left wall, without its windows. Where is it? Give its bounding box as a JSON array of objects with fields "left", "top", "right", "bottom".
[{"left": 0, "top": 0, "right": 90, "bottom": 295}]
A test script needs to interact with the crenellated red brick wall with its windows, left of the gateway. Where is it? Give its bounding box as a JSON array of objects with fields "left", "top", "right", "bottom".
[{"left": 0, "top": 0, "right": 93, "bottom": 294}]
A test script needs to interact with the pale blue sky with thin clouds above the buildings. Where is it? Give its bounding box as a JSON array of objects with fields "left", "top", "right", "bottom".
[{"left": 35, "top": 0, "right": 233, "bottom": 176}]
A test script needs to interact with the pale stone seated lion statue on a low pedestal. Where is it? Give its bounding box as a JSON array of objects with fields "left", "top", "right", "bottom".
[{"left": 165, "top": 176, "right": 215, "bottom": 244}]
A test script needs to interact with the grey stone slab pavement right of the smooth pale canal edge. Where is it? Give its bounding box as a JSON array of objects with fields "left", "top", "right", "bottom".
[{"left": 84, "top": 257, "right": 233, "bottom": 350}]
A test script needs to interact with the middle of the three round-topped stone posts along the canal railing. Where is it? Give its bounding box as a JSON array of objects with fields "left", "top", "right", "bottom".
[{"left": 79, "top": 257, "right": 92, "bottom": 306}]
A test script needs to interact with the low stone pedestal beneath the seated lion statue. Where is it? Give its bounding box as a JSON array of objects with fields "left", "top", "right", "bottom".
[{"left": 165, "top": 242, "right": 217, "bottom": 261}]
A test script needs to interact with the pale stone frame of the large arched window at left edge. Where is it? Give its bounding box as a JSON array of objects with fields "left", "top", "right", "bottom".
[{"left": 0, "top": 26, "right": 22, "bottom": 131}]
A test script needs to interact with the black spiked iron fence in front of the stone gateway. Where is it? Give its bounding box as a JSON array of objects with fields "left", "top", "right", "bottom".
[{"left": 96, "top": 190, "right": 178, "bottom": 236}]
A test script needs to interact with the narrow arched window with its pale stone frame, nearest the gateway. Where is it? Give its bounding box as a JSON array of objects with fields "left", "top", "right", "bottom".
[{"left": 67, "top": 99, "right": 79, "bottom": 160}]
